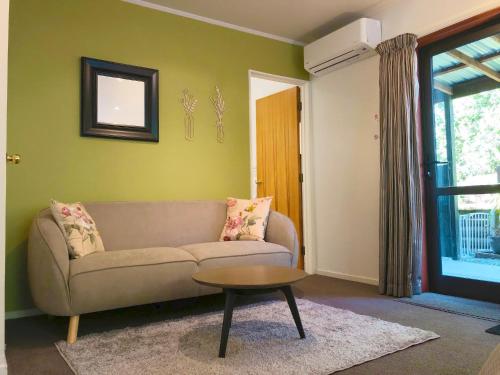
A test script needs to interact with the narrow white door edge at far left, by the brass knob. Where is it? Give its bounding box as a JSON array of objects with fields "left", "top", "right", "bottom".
[{"left": 0, "top": 0, "right": 9, "bottom": 374}]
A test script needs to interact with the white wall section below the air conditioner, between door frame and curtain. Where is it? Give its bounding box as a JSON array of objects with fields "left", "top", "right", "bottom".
[{"left": 312, "top": 57, "right": 379, "bottom": 284}]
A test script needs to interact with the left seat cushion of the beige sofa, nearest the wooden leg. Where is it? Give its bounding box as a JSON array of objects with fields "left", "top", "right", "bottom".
[{"left": 69, "top": 247, "right": 198, "bottom": 314}]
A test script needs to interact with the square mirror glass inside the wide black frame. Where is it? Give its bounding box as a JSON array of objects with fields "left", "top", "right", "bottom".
[{"left": 97, "top": 75, "right": 145, "bottom": 127}]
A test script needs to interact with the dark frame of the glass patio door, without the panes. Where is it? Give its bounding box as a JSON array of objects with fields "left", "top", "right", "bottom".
[{"left": 418, "top": 18, "right": 500, "bottom": 303}]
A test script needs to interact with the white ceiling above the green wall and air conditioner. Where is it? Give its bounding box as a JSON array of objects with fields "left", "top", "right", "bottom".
[{"left": 129, "top": 0, "right": 383, "bottom": 43}]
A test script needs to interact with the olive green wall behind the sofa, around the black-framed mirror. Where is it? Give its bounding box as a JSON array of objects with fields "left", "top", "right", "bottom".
[{"left": 6, "top": 0, "right": 308, "bottom": 311}]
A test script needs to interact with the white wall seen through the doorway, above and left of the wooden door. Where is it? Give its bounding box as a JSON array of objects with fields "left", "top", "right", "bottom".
[{"left": 250, "top": 77, "right": 294, "bottom": 198}]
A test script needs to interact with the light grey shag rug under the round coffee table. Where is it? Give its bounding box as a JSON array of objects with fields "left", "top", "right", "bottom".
[{"left": 56, "top": 299, "right": 439, "bottom": 375}]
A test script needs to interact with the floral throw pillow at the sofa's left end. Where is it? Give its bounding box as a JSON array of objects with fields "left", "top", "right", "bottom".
[{"left": 50, "top": 200, "right": 104, "bottom": 258}]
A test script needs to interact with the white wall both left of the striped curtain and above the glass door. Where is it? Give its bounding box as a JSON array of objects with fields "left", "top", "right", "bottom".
[{"left": 310, "top": 0, "right": 500, "bottom": 284}]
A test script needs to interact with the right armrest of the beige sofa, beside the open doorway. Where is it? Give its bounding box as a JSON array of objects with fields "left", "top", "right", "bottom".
[{"left": 265, "top": 211, "right": 299, "bottom": 267}]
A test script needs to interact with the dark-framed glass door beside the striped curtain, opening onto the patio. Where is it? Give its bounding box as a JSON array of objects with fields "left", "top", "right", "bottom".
[{"left": 419, "top": 20, "right": 500, "bottom": 302}]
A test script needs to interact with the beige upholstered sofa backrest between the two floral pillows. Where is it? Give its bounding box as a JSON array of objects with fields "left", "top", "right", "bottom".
[{"left": 41, "top": 201, "right": 226, "bottom": 250}]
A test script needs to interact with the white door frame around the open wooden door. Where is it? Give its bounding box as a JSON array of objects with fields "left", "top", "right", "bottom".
[{"left": 248, "top": 69, "right": 316, "bottom": 274}]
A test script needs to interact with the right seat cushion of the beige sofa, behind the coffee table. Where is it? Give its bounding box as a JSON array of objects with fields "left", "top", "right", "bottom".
[{"left": 181, "top": 241, "right": 292, "bottom": 269}]
